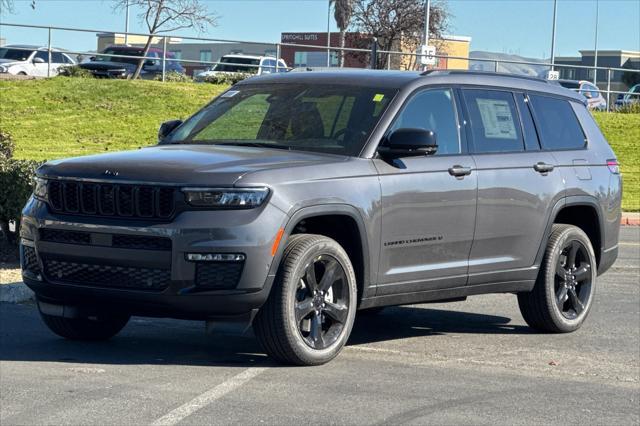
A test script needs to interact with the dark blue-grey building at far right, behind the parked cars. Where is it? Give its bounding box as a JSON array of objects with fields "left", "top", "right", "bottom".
[{"left": 555, "top": 50, "right": 640, "bottom": 96}]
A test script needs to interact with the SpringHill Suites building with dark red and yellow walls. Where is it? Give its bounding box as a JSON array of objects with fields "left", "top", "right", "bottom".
[{"left": 280, "top": 32, "right": 471, "bottom": 70}]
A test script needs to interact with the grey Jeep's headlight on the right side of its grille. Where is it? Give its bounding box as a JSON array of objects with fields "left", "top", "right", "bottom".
[{"left": 182, "top": 188, "right": 269, "bottom": 209}]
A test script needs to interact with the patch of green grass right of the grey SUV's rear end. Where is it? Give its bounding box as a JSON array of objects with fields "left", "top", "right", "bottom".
[{"left": 594, "top": 112, "right": 640, "bottom": 212}]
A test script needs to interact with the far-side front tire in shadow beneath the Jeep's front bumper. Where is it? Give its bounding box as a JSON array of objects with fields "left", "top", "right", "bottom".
[{"left": 40, "top": 312, "right": 129, "bottom": 340}]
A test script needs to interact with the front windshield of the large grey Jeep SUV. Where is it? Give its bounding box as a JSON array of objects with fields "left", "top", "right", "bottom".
[{"left": 165, "top": 84, "right": 396, "bottom": 156}]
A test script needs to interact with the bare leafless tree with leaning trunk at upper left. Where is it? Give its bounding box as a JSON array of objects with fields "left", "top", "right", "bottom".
[{"left": 114, "top": 0, "right": 218, "bottom": 79}]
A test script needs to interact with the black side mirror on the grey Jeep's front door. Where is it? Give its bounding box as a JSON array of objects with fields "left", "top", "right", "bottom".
[{"left": 378, "top": 129, "right": 438, "bottom": 158}]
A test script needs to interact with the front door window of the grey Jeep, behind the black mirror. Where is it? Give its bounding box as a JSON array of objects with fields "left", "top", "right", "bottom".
[{"left": 390, "top": 89, "right": 460, "bottom": 155}]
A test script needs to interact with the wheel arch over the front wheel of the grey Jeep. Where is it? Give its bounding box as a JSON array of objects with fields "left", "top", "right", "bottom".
[{"left": 269, "top": 204, "right": 371, "bottom": 302}]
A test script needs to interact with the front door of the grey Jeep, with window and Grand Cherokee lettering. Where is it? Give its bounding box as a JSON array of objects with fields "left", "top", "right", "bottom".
[{"left": 373, "top": 88, "right": 477, "bottom": 295}]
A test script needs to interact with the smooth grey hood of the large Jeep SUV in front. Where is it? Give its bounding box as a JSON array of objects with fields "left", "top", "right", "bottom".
[{"left": 38, "top": 145, "right": 347, "bottom": 186}]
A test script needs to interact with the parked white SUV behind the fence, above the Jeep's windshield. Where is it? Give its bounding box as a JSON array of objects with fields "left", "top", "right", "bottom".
[{"left": 195, "top": 54, "right": 288, "bottom": 81}]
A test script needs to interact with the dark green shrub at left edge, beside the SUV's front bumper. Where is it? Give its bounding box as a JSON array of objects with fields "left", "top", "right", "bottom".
[{"left": 0, "top": 157, "right": 41, "bottom": 245}]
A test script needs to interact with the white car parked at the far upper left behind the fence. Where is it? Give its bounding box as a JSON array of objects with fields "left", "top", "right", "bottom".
[{"left": 0, "top": 45, "right": 76, "bottom": 77}]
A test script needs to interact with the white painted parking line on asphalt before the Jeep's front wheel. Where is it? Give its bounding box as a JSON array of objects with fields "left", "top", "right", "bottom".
[{"left": 151, "top": 368, "right": 266, "bottom": 426}]
